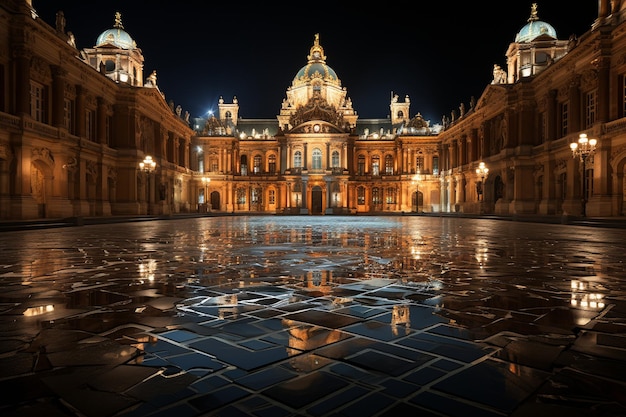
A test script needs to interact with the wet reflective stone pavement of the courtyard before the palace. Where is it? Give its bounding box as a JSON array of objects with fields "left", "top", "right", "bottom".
[{"left": 0, "top": 216, "right": 626, "bottom": 417}]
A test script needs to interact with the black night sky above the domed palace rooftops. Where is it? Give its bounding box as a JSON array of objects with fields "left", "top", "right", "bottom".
[{"left": 33, "top": 0, "right": 598, "bottom": 124}]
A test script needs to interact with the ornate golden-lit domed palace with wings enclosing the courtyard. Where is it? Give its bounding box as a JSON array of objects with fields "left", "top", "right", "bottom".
[{"left": 0, "top": 0, "right": 626, "bottom": 220}]
